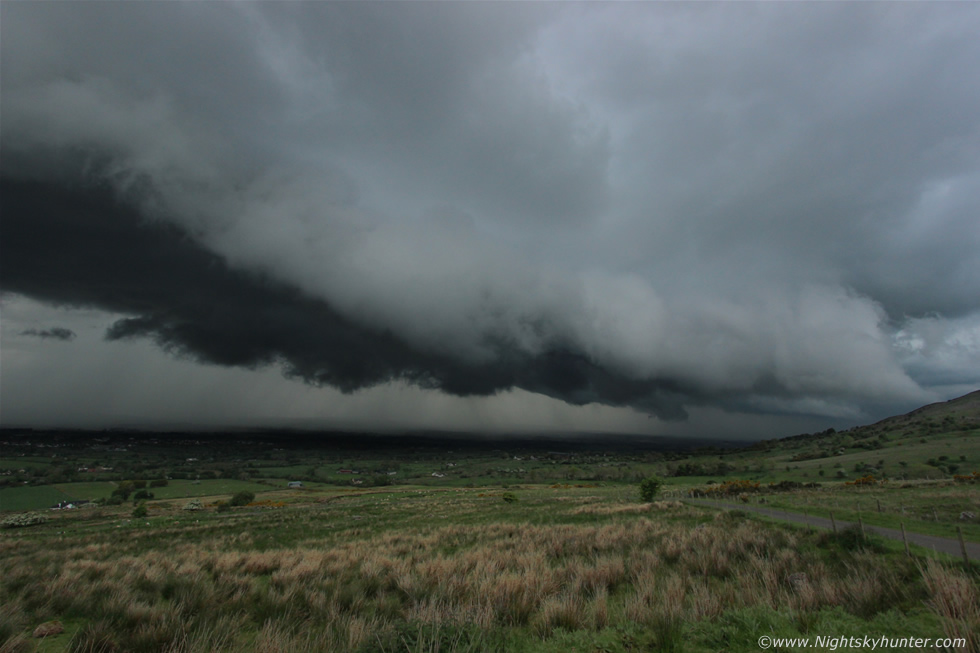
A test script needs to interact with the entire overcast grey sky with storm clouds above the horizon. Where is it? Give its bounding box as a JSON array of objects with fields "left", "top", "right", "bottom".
[{"left": 0, "top": 1, "right": 980, "bottom": 437}]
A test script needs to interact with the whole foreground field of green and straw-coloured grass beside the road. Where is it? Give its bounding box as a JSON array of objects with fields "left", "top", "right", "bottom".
[{"left": 0, "top": 486, "right": 980, "bottom": 653}]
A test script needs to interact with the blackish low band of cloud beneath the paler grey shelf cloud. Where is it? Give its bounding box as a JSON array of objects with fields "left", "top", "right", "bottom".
[{"left": 0, "top": 182, "right": 684, "bottom": 418}]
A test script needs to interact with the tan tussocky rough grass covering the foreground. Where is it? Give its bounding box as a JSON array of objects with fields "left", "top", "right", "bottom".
[{"left": 0, "top": 488, "right": 980, "bottom": 653}]
